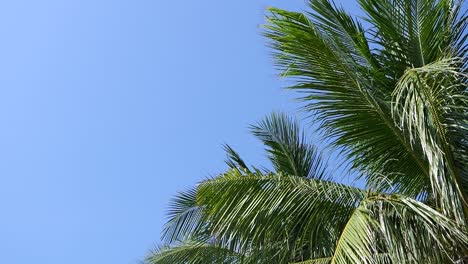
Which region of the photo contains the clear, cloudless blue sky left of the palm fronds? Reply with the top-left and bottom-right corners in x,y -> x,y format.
0,0 -> 362,264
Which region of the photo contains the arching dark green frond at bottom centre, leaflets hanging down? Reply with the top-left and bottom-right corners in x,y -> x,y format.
197,170 -> 365,261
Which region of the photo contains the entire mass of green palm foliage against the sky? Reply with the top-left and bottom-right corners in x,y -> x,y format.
147,0 -> 468,263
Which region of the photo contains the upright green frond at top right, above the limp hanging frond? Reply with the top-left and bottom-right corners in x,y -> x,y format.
359,0 -> 464,69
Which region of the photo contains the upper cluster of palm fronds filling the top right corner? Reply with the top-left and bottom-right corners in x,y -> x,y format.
265,0 -> 468,217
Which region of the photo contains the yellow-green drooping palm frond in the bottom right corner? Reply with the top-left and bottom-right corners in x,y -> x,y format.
292,193 -> 468,264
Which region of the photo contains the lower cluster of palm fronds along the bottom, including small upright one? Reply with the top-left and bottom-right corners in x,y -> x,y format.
147,114 -> 468,264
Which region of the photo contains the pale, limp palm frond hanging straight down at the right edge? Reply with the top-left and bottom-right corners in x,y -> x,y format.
393,59 -> 468,222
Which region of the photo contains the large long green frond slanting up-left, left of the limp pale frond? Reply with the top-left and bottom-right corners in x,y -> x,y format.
266,1 -> 430,196
